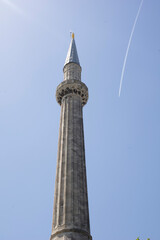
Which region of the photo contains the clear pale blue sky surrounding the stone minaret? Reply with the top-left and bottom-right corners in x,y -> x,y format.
0,0 -> 160,240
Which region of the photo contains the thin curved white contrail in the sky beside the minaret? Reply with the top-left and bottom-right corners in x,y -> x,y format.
119,0 -> 143,97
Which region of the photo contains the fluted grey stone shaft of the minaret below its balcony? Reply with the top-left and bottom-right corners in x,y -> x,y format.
51,88 -> 90,240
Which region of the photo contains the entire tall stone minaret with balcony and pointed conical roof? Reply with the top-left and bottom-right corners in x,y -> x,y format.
50,34 -> 92,240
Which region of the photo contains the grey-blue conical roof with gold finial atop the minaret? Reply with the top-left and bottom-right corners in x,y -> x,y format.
64,33 -> 80,65
